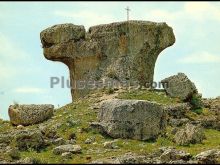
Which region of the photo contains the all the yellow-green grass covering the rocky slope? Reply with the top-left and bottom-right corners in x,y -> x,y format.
0,90 -> 220,163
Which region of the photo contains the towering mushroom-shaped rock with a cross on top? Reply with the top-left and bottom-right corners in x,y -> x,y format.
40,21 -> 175,100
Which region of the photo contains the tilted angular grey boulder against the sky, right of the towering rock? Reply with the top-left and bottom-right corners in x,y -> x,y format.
161,73 -> 198,101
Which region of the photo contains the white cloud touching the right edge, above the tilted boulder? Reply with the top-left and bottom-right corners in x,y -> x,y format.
179,52 -> 220,64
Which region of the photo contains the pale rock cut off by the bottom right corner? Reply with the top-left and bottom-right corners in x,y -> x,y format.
195,149 -> 220,164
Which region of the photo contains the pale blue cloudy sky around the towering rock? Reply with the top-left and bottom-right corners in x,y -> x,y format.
0,2 -> 220,119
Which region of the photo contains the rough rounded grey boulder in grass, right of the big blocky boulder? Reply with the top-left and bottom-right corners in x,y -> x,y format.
174,123 -> 205,145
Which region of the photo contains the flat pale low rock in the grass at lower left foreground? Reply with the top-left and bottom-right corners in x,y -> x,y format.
53,144 -> 82,155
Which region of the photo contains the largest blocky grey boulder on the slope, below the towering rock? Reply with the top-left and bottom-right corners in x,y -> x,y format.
91,99 -> 166,140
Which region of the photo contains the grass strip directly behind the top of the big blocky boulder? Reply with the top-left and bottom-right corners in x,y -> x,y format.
118,89 -> 180,105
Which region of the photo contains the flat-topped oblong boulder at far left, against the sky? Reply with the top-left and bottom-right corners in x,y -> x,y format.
8,104 -> 54,126
